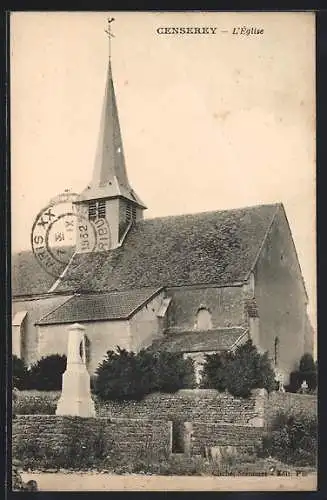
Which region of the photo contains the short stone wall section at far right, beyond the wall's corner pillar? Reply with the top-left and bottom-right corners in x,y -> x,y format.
265,392 -> 318,427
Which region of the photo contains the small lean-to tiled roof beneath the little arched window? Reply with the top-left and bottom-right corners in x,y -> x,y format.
152,327 -> 246,352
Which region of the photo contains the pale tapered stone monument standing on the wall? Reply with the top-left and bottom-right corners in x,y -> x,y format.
56,323 -> 95,417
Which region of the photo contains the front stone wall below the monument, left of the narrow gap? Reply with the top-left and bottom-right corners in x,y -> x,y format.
12,415 -> 172,470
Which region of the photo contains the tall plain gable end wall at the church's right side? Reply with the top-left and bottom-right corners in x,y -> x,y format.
255,205 -> 309,383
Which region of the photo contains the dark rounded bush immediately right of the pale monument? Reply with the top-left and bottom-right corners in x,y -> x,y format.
95,347 -> 195,400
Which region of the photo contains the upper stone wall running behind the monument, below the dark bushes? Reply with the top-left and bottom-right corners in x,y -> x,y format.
13,389 -> 264,425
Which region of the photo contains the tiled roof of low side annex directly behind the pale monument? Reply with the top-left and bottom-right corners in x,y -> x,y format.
37,288 -> 160,325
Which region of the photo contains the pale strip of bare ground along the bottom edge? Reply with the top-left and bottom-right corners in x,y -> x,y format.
22,472 -> 317,491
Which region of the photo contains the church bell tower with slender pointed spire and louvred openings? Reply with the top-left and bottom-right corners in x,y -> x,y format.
75,18 -> 146,253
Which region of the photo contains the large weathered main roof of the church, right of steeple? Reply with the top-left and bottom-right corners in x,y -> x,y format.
52,204 -> 281,292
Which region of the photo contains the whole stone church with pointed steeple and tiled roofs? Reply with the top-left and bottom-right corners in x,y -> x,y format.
12,41 -> 313,380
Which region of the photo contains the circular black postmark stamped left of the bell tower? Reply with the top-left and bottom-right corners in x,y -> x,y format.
31,192 -> 111,278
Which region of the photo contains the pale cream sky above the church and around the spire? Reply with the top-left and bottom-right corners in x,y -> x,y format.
10,12 -> 316,338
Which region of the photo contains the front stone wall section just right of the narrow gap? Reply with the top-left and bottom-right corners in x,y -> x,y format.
190,422 -> 264,455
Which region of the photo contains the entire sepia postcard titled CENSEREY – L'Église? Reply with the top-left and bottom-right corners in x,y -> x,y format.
9,11 -> 317,491
